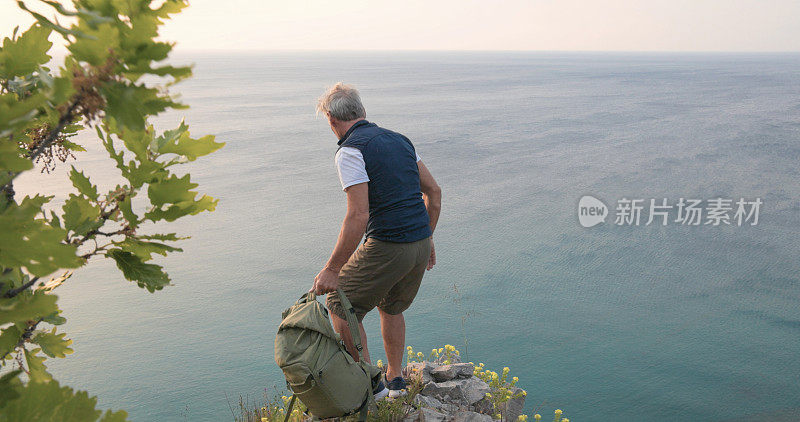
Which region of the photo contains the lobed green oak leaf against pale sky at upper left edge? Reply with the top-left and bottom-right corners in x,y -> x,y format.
0,24 -> 53,79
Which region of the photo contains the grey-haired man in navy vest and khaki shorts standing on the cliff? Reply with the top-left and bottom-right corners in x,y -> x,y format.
312,83 -> 441,398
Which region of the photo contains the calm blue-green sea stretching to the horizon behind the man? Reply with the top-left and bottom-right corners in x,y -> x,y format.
15,52 -> 800,422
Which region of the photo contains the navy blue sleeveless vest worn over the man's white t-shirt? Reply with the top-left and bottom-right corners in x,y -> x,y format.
339,120 -> 431,243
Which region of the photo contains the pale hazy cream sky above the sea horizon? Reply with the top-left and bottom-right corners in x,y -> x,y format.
0,0 -> 800,51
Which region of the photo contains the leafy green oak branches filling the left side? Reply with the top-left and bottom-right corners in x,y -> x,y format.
0,0 -> 223,421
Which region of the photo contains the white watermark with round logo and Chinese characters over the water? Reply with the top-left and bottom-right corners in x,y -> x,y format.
578,195 -> 764,227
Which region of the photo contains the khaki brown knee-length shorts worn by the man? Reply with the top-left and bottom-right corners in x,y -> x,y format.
327,237 -> 431,321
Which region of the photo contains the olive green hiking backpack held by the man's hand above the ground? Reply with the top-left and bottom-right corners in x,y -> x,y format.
275,289 -> 381,421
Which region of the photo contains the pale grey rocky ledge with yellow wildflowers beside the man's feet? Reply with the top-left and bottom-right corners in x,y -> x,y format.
403,355 -> 525,422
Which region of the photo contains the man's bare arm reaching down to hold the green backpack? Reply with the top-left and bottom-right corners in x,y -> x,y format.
311,183 -> 369,295
